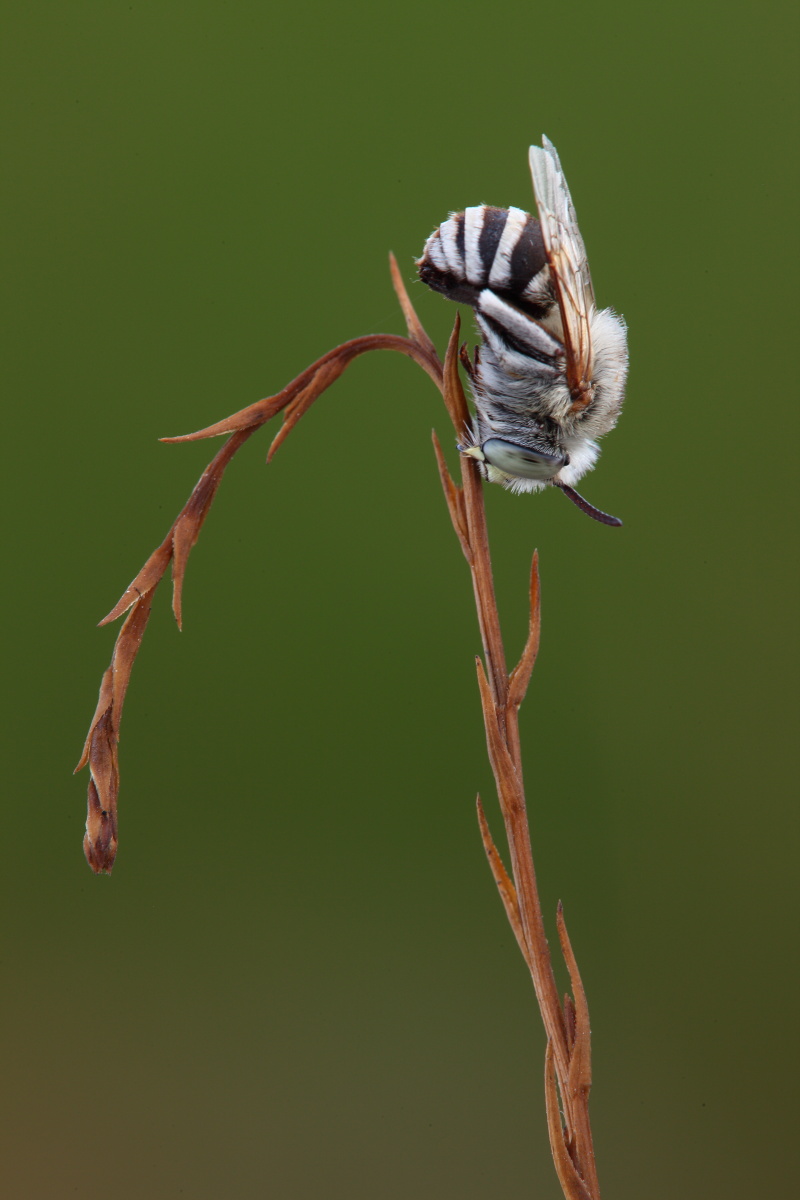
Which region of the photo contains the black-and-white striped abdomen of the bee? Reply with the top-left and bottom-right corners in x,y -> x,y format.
417,204 -> 549,316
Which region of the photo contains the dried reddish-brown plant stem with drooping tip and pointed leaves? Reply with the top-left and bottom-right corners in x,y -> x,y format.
76,256 -> 600,1200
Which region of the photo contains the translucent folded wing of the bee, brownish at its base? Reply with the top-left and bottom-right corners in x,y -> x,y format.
530,137 -> 595,408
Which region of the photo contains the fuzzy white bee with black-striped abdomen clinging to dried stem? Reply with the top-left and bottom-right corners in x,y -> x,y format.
417,138 -> 627,526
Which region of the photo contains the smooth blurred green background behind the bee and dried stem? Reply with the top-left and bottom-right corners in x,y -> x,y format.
0,0 -> 798,1200
